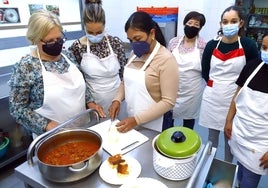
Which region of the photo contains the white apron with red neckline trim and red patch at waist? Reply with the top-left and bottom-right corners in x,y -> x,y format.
199,38 -> 246,131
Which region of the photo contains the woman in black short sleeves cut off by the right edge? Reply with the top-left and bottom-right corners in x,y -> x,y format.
224,35 -> 268,188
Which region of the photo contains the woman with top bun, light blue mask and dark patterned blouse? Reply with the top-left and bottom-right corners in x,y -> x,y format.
69,0 -> 126,118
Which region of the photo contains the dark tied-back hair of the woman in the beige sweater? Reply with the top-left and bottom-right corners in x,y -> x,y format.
125,11 -> 166,47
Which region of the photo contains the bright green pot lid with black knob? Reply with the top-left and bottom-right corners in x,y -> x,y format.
156,126 -> 201,158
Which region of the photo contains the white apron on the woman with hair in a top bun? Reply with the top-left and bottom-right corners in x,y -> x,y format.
81,36 -> 121,114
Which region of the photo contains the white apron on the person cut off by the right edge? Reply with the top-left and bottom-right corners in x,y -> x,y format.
229,63 -> 268,175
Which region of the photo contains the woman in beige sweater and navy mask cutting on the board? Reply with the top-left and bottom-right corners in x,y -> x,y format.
109,12 -> 178,132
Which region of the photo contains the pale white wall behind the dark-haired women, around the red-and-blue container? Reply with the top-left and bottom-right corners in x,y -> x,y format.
103,0 -> 235,42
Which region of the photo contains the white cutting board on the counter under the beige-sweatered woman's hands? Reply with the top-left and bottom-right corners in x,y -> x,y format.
88,120 -> 149,155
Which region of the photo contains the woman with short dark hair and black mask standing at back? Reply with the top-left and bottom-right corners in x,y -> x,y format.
168,11 -> 206,129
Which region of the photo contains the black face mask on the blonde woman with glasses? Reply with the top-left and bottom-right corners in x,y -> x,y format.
42,39 -> 64,56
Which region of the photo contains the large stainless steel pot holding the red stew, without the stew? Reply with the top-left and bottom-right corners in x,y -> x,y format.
27,109 -> 103,182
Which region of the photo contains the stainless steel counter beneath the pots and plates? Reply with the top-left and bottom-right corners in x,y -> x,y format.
15,129 -> 216,188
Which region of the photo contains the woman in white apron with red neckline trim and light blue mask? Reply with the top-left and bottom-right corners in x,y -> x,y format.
199,6 -> 258,162
